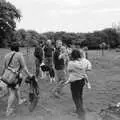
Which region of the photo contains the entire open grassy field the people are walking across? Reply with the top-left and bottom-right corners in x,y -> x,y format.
0,49 -> 120,120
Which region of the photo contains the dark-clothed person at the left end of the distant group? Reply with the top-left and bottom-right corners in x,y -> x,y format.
34,44 -> 43,79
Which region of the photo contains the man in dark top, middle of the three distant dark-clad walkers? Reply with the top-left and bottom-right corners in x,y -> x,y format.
43,40 -> 54,79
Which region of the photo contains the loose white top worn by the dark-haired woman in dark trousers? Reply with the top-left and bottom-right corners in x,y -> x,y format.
68,58 -> 92,82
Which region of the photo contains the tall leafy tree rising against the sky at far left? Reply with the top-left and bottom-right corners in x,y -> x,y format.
0,1 -> 21,46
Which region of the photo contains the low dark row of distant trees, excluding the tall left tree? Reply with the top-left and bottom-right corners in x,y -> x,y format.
4,28 -> 120,49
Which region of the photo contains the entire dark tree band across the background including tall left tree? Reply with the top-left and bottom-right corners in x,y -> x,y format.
0,0 -> 120,49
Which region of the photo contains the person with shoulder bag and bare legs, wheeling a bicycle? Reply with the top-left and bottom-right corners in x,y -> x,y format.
2,43 -> 32,116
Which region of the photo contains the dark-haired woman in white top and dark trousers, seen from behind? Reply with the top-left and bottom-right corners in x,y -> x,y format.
68,49 -> 92,115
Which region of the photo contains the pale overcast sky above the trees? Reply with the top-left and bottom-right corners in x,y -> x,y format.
6,0 -> 120,33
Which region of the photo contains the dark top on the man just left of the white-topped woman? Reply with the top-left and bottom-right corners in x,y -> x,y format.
53,49 -> 64,70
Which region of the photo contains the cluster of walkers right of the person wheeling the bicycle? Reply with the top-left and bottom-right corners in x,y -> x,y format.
34,40 -> 92,114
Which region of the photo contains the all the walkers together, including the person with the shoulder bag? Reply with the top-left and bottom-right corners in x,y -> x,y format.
1,40 -> 92,116
